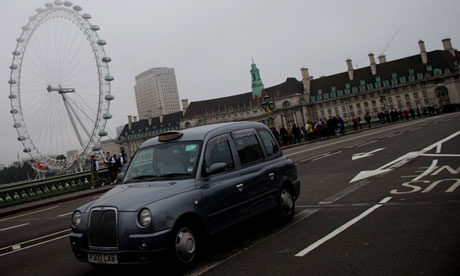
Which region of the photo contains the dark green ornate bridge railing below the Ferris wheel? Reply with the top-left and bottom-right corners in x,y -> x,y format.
0,169 -> 110,208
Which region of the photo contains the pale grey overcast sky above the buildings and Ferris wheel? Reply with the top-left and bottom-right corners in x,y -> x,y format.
0,0 -> 460,165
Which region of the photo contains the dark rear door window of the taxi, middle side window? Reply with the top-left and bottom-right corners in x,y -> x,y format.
232,130 -> 264,166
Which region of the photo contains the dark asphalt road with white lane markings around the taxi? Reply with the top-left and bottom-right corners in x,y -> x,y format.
0,113 -> 460,276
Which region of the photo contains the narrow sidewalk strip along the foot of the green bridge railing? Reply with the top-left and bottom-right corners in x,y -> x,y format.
0,185 -> 115,218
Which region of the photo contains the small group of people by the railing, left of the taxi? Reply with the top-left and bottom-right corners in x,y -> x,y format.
90,148 -> 128,188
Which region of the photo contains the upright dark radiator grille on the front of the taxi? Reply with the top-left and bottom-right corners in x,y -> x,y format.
88,208 -> 118,248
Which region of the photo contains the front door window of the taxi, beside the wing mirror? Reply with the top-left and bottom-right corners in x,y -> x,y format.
205,135 -> 235,170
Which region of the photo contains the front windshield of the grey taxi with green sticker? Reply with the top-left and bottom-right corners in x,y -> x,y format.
123,141 -> 200,183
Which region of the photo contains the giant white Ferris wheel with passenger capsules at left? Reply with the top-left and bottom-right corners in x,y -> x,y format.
8,0 -> 114,169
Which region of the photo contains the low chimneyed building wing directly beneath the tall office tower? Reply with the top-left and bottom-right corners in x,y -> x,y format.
117,111 -> 183,158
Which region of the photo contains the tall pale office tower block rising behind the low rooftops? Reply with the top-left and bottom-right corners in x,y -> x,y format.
134,67 -> 181,120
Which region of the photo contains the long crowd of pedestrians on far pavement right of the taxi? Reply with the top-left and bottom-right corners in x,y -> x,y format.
272,104 -> 460,146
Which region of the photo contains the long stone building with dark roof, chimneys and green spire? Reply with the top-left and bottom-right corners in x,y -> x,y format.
181,39 -> 460,129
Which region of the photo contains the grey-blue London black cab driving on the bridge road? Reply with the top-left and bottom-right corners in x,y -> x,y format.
70,122 -> 300,266
